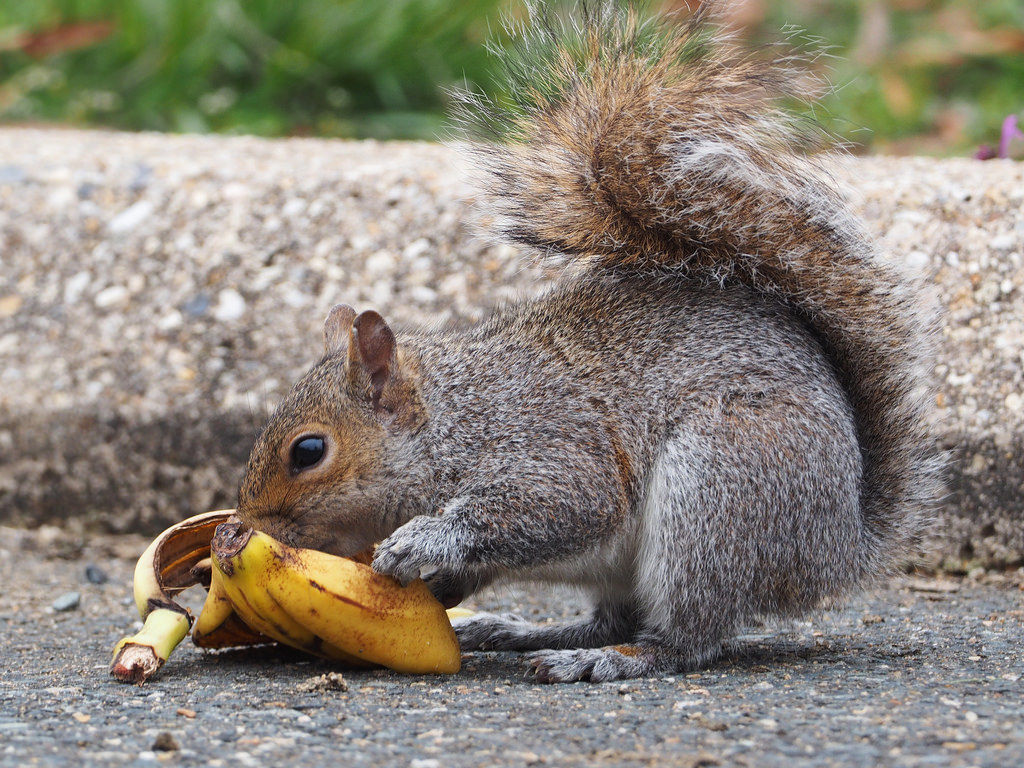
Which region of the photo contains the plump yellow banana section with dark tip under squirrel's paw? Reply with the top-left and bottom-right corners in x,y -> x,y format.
211,522 -> 461,673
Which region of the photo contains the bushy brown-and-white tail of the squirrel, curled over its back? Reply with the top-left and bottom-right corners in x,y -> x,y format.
461,3 -> 939,572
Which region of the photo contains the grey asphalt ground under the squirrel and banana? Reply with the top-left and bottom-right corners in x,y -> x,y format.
0,528 -> 1024,768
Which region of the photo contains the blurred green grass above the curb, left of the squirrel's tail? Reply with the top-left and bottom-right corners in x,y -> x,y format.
0,0 -> 499,138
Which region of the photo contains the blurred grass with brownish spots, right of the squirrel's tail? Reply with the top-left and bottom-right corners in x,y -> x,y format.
744,0 -> 1024,155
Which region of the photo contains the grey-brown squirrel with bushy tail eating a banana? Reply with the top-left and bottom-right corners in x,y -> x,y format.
237,3 -> 941,682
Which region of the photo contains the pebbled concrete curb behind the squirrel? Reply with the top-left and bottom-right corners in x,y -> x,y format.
0,128 -> 1024,570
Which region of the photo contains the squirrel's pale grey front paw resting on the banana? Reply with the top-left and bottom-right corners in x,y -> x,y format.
373,515 -> 456,587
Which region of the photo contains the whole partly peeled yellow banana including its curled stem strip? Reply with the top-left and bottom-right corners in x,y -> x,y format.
111,510 -> 465,683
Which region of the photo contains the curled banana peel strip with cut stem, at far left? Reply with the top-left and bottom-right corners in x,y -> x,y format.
111,510 -> 234,683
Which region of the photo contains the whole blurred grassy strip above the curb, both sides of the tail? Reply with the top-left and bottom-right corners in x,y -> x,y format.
0,0 -> 1024,154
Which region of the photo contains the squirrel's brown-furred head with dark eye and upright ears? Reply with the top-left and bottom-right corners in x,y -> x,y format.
238,304 -> 426,556
